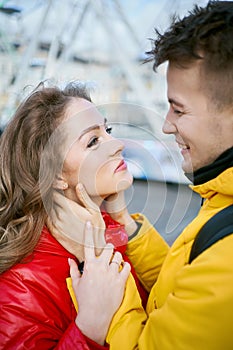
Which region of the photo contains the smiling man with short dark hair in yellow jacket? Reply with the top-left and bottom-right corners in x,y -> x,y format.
56,1 -> 233,350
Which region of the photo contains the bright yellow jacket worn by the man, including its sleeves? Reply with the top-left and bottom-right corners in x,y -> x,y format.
67,168 -> 233,350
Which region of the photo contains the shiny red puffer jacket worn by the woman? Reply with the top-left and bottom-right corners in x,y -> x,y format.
0,228 -> 106,350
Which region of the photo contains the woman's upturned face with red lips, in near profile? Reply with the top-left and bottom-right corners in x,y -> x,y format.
59,98 -> 133,203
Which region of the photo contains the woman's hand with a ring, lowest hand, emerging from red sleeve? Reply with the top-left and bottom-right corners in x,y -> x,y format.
69,223 -> 130,345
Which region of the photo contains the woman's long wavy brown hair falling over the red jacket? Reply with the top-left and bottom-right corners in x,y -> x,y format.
0,82 -> 91,273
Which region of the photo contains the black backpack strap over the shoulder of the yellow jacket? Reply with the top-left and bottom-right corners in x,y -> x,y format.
189,205 -> 233,263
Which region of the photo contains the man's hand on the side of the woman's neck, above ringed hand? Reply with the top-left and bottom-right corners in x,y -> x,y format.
47,184 -> 106,261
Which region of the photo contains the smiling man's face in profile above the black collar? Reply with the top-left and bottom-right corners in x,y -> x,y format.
163,63 -> 233,173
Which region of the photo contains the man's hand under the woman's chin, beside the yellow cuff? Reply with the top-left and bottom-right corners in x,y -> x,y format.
103,191 -> 137,236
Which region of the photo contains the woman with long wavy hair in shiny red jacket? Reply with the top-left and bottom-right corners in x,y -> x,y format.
0,83 -> 146,350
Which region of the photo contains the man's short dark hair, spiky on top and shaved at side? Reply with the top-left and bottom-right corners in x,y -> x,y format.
146,1 -> 233,109
